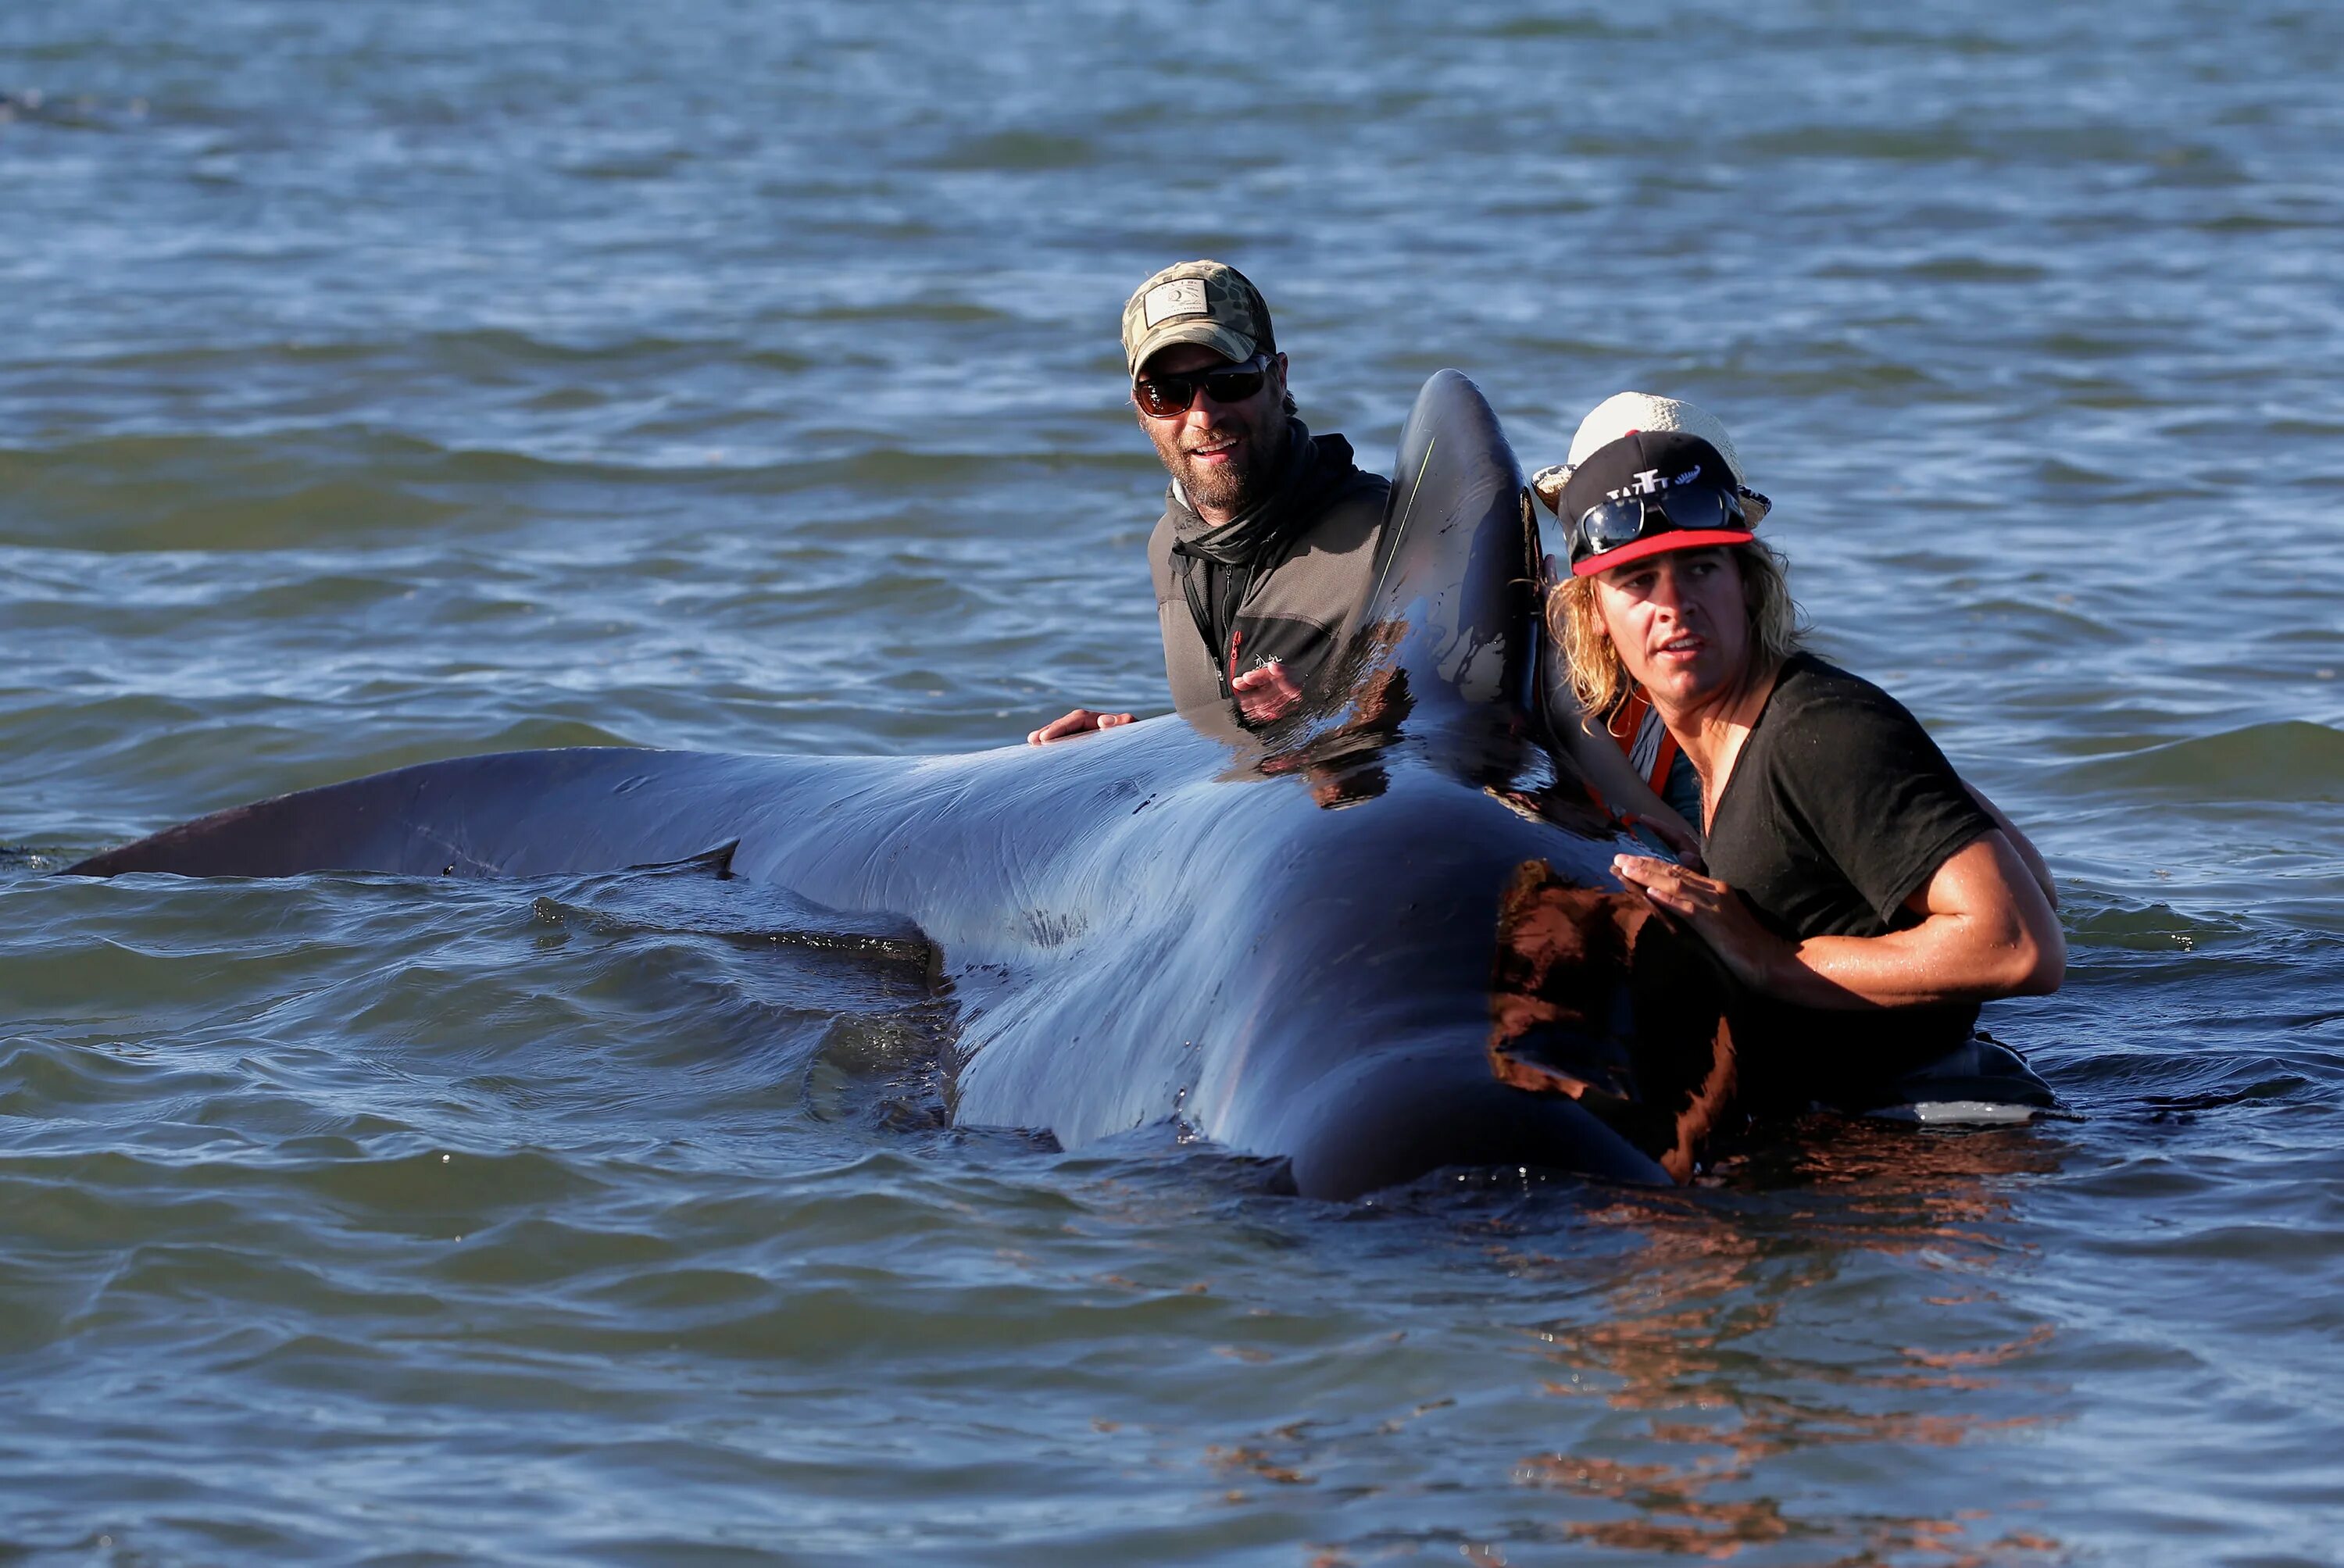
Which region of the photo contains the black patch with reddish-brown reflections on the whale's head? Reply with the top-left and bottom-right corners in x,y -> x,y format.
1488,860 -> 1735,1181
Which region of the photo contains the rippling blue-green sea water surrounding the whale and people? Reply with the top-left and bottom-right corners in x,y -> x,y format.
0,0 -> 2344,1566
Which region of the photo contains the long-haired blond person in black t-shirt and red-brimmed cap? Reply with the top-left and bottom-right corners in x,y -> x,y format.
1540,394 -> 2067,1102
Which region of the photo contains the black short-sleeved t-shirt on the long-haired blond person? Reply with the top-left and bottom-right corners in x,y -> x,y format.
1704,654 -> 1995,1099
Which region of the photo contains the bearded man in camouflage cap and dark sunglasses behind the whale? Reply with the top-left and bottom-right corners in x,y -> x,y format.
1027,260 -> 1390,743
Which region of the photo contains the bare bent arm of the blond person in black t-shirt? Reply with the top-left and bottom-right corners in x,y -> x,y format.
1613,832 -> 2067,1010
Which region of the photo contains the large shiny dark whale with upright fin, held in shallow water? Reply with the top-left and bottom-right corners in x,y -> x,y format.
73,370 -> 1763,1198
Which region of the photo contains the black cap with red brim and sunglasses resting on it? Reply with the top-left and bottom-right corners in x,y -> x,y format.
1554,431 -> 1770,577
